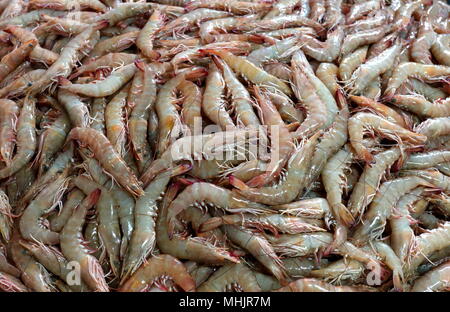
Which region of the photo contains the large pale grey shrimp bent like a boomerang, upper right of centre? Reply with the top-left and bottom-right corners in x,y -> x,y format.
291,51 -> 338,138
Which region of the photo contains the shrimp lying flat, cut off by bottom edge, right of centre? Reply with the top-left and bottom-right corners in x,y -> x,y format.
275,278 -> 377,292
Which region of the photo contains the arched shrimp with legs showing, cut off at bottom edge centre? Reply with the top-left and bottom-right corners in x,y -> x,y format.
197,263 -> 262,292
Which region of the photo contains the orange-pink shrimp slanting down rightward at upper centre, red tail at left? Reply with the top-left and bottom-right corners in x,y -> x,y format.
202,49 -> 292,95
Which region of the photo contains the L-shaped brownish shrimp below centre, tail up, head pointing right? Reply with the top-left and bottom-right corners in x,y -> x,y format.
156,184 -> 239,265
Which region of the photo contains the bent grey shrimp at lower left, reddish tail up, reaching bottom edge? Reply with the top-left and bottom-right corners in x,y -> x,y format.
61,189 -> 109,292
